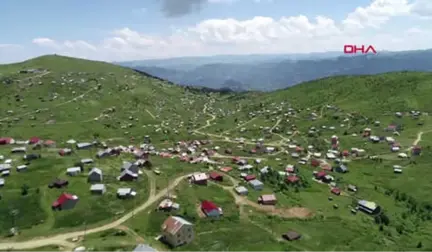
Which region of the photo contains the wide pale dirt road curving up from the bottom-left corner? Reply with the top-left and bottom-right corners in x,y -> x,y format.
0,175 -> 189,250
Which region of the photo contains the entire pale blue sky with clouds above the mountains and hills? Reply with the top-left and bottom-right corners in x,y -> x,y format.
0,0 -> 432,63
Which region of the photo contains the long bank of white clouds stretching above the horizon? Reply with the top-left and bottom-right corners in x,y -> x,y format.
33,0 -> 432,60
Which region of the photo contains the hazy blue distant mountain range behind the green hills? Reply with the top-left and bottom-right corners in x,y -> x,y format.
117,50 -> 432,91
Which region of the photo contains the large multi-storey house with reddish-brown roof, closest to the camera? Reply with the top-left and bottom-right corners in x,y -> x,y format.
161,216 -> 194,247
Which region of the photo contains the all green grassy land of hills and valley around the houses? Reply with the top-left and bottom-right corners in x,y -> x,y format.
0,56 -> 432,252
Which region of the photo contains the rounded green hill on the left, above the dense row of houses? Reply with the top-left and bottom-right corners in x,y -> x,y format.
0,56 -> 216,142
